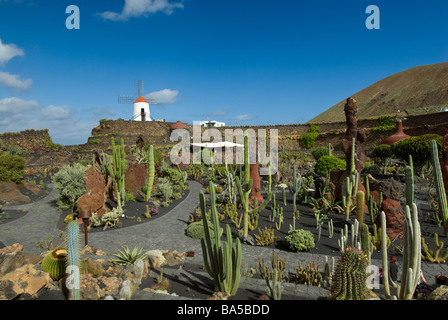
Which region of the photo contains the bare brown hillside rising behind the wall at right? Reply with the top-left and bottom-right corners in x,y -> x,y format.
308,62 -> 448,123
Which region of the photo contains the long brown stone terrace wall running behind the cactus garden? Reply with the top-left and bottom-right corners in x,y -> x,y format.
0,112 -> 448,172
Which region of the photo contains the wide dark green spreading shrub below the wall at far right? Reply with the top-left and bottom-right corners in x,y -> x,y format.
392,134 -> 443,172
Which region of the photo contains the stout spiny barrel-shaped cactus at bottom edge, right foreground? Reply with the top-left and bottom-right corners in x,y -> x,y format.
330,247 -> 368,300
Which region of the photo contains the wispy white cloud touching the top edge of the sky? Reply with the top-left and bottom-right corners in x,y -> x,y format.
99,0 -> 184,21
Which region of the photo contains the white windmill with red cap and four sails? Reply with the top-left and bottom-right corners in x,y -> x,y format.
118,80 -> 157,121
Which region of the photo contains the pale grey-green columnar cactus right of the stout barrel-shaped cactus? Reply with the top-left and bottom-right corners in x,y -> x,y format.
381,203 -> 422,300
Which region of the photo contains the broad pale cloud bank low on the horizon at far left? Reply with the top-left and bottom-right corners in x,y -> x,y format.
0,97 -> 97,145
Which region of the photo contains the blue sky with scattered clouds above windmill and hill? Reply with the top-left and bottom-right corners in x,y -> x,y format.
0,0 -> 448,145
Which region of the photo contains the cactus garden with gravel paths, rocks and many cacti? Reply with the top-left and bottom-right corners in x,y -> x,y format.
0,108 -> 448,301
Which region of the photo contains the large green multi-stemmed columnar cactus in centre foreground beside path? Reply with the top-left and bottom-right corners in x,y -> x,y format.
199,182 -> 241,296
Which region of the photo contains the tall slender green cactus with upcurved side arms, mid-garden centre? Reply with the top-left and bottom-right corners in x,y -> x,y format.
235,131 -> 272,240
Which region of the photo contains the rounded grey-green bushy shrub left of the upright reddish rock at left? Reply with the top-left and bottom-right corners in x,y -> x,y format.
53,163 -> 87,210
